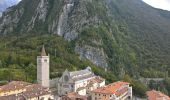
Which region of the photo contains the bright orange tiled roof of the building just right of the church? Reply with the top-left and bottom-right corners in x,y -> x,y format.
92,81 -> 129,95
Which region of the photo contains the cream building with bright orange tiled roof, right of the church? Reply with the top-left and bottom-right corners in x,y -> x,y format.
91,81 -> 132,100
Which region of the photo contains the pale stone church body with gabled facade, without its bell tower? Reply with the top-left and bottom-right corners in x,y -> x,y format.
58,67 -> 105,95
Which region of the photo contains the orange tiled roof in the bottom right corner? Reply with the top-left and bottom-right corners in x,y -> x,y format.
146,90 -> 170,100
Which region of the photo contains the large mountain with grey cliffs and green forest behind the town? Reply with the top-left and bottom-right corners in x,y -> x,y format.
0,0 -> 170,96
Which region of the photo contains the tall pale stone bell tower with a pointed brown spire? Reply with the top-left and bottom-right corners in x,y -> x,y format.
37,45 -> 50,88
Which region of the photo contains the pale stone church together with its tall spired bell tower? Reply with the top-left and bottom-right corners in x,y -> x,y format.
37,46 -> 105,96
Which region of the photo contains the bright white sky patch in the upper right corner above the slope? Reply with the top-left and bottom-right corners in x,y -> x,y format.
143,0 -> 170,11
